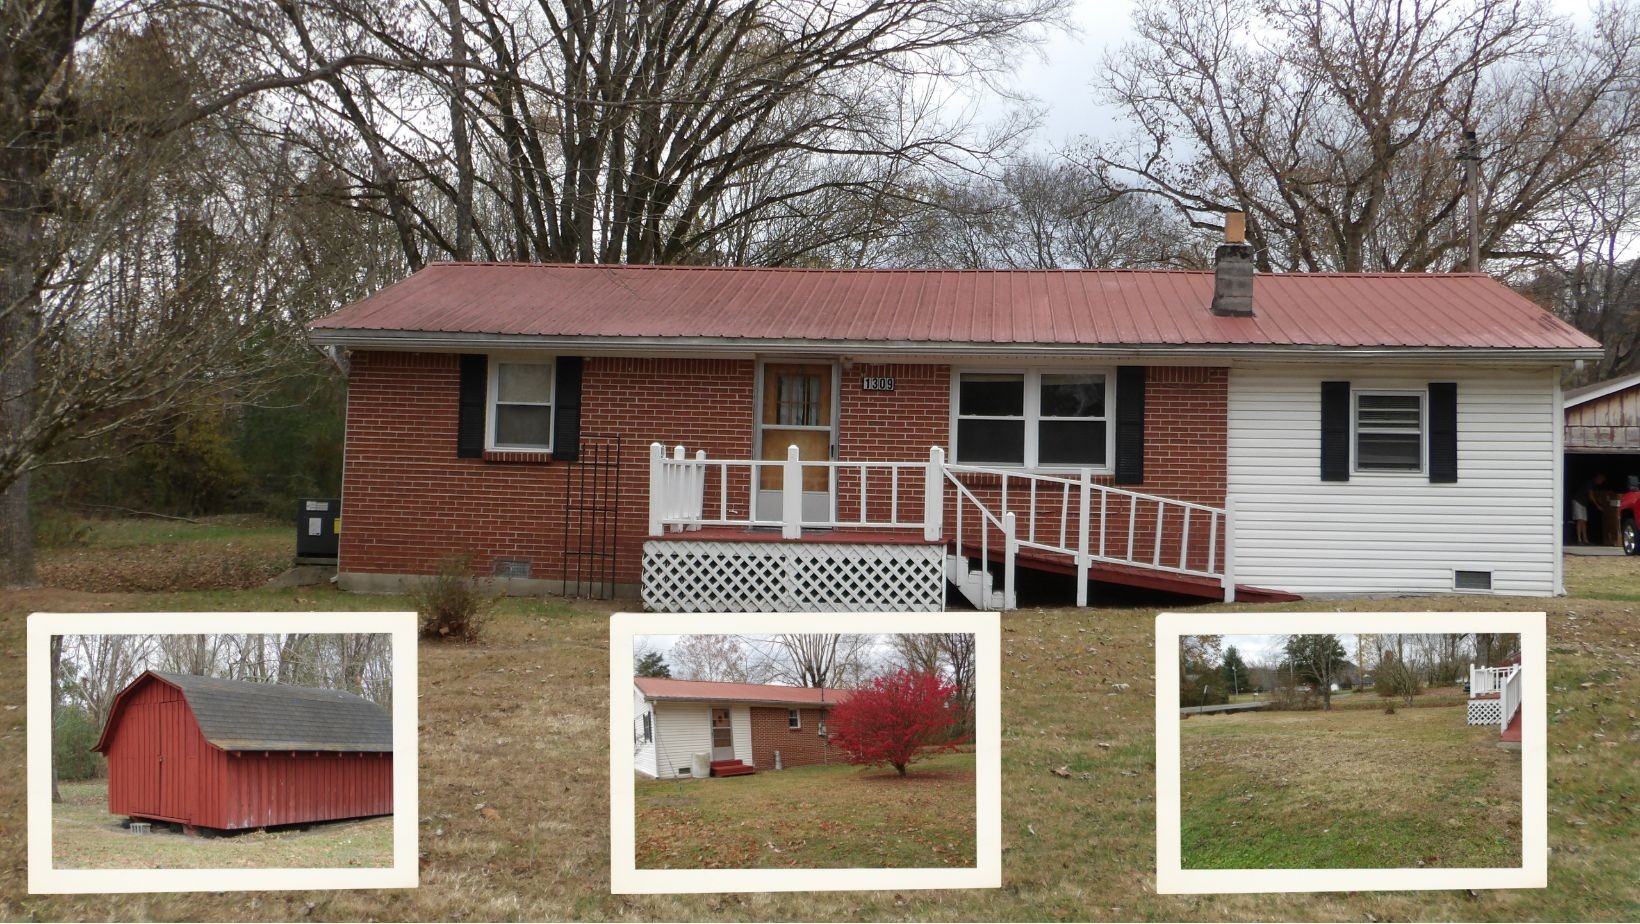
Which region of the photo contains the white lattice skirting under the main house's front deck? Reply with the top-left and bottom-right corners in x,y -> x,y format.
643,538 -> 945,612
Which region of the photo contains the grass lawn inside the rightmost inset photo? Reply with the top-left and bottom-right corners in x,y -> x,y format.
1179,706 -> 1520,870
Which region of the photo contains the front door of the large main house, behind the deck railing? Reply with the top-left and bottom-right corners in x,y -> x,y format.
758,363 -> 836,522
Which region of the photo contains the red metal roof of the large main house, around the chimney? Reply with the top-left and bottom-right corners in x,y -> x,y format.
312,263 -> 1599,350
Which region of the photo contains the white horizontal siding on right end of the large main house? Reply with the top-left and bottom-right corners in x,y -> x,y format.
1228,364 -> 1560,596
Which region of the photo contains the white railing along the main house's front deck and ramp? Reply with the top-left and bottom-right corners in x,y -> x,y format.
649,443 -> 1235,606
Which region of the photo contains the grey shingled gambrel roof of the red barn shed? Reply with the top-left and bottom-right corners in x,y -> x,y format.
92,671 -> 394,753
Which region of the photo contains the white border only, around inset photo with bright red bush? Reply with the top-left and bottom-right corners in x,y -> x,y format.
610,612 -> 1002,894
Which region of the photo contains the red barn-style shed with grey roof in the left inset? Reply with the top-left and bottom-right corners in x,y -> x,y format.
92,671 -> 394,830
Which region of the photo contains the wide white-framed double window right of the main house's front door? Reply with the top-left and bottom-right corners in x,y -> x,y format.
953,371 -> 1110,468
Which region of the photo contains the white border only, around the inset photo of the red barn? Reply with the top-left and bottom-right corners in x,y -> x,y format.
26,612 -> 421,894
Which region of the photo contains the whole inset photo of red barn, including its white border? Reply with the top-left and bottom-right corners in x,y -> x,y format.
26,612 -> 420,894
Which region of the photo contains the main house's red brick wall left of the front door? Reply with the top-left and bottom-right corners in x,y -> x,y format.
339,351 -> 754,583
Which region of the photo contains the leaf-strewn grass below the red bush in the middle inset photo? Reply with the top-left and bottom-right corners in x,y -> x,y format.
636,753 -> 976,870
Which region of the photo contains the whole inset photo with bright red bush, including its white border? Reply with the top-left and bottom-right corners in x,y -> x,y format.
610,612 -> 1002,894
